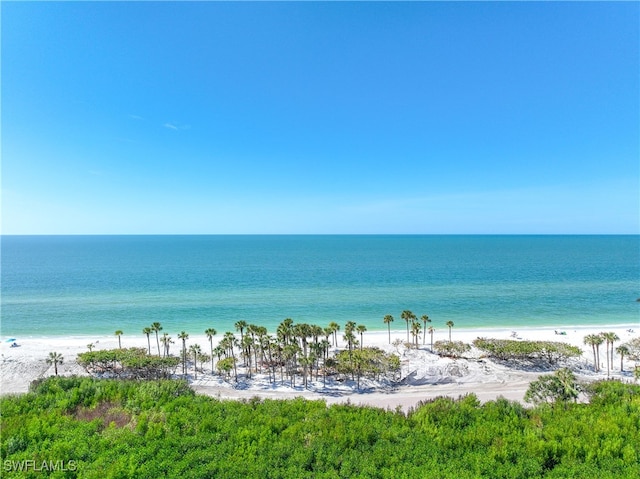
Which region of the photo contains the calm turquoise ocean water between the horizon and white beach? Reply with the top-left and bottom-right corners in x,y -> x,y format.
1,235 -> 640,337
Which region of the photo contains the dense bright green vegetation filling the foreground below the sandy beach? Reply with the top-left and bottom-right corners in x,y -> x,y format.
0,377 -> 640,479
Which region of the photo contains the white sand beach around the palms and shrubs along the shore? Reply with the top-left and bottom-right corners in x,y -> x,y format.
0,325 -> 640,411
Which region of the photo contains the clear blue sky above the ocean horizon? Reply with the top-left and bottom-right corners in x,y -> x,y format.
1,2 -> 640,234
